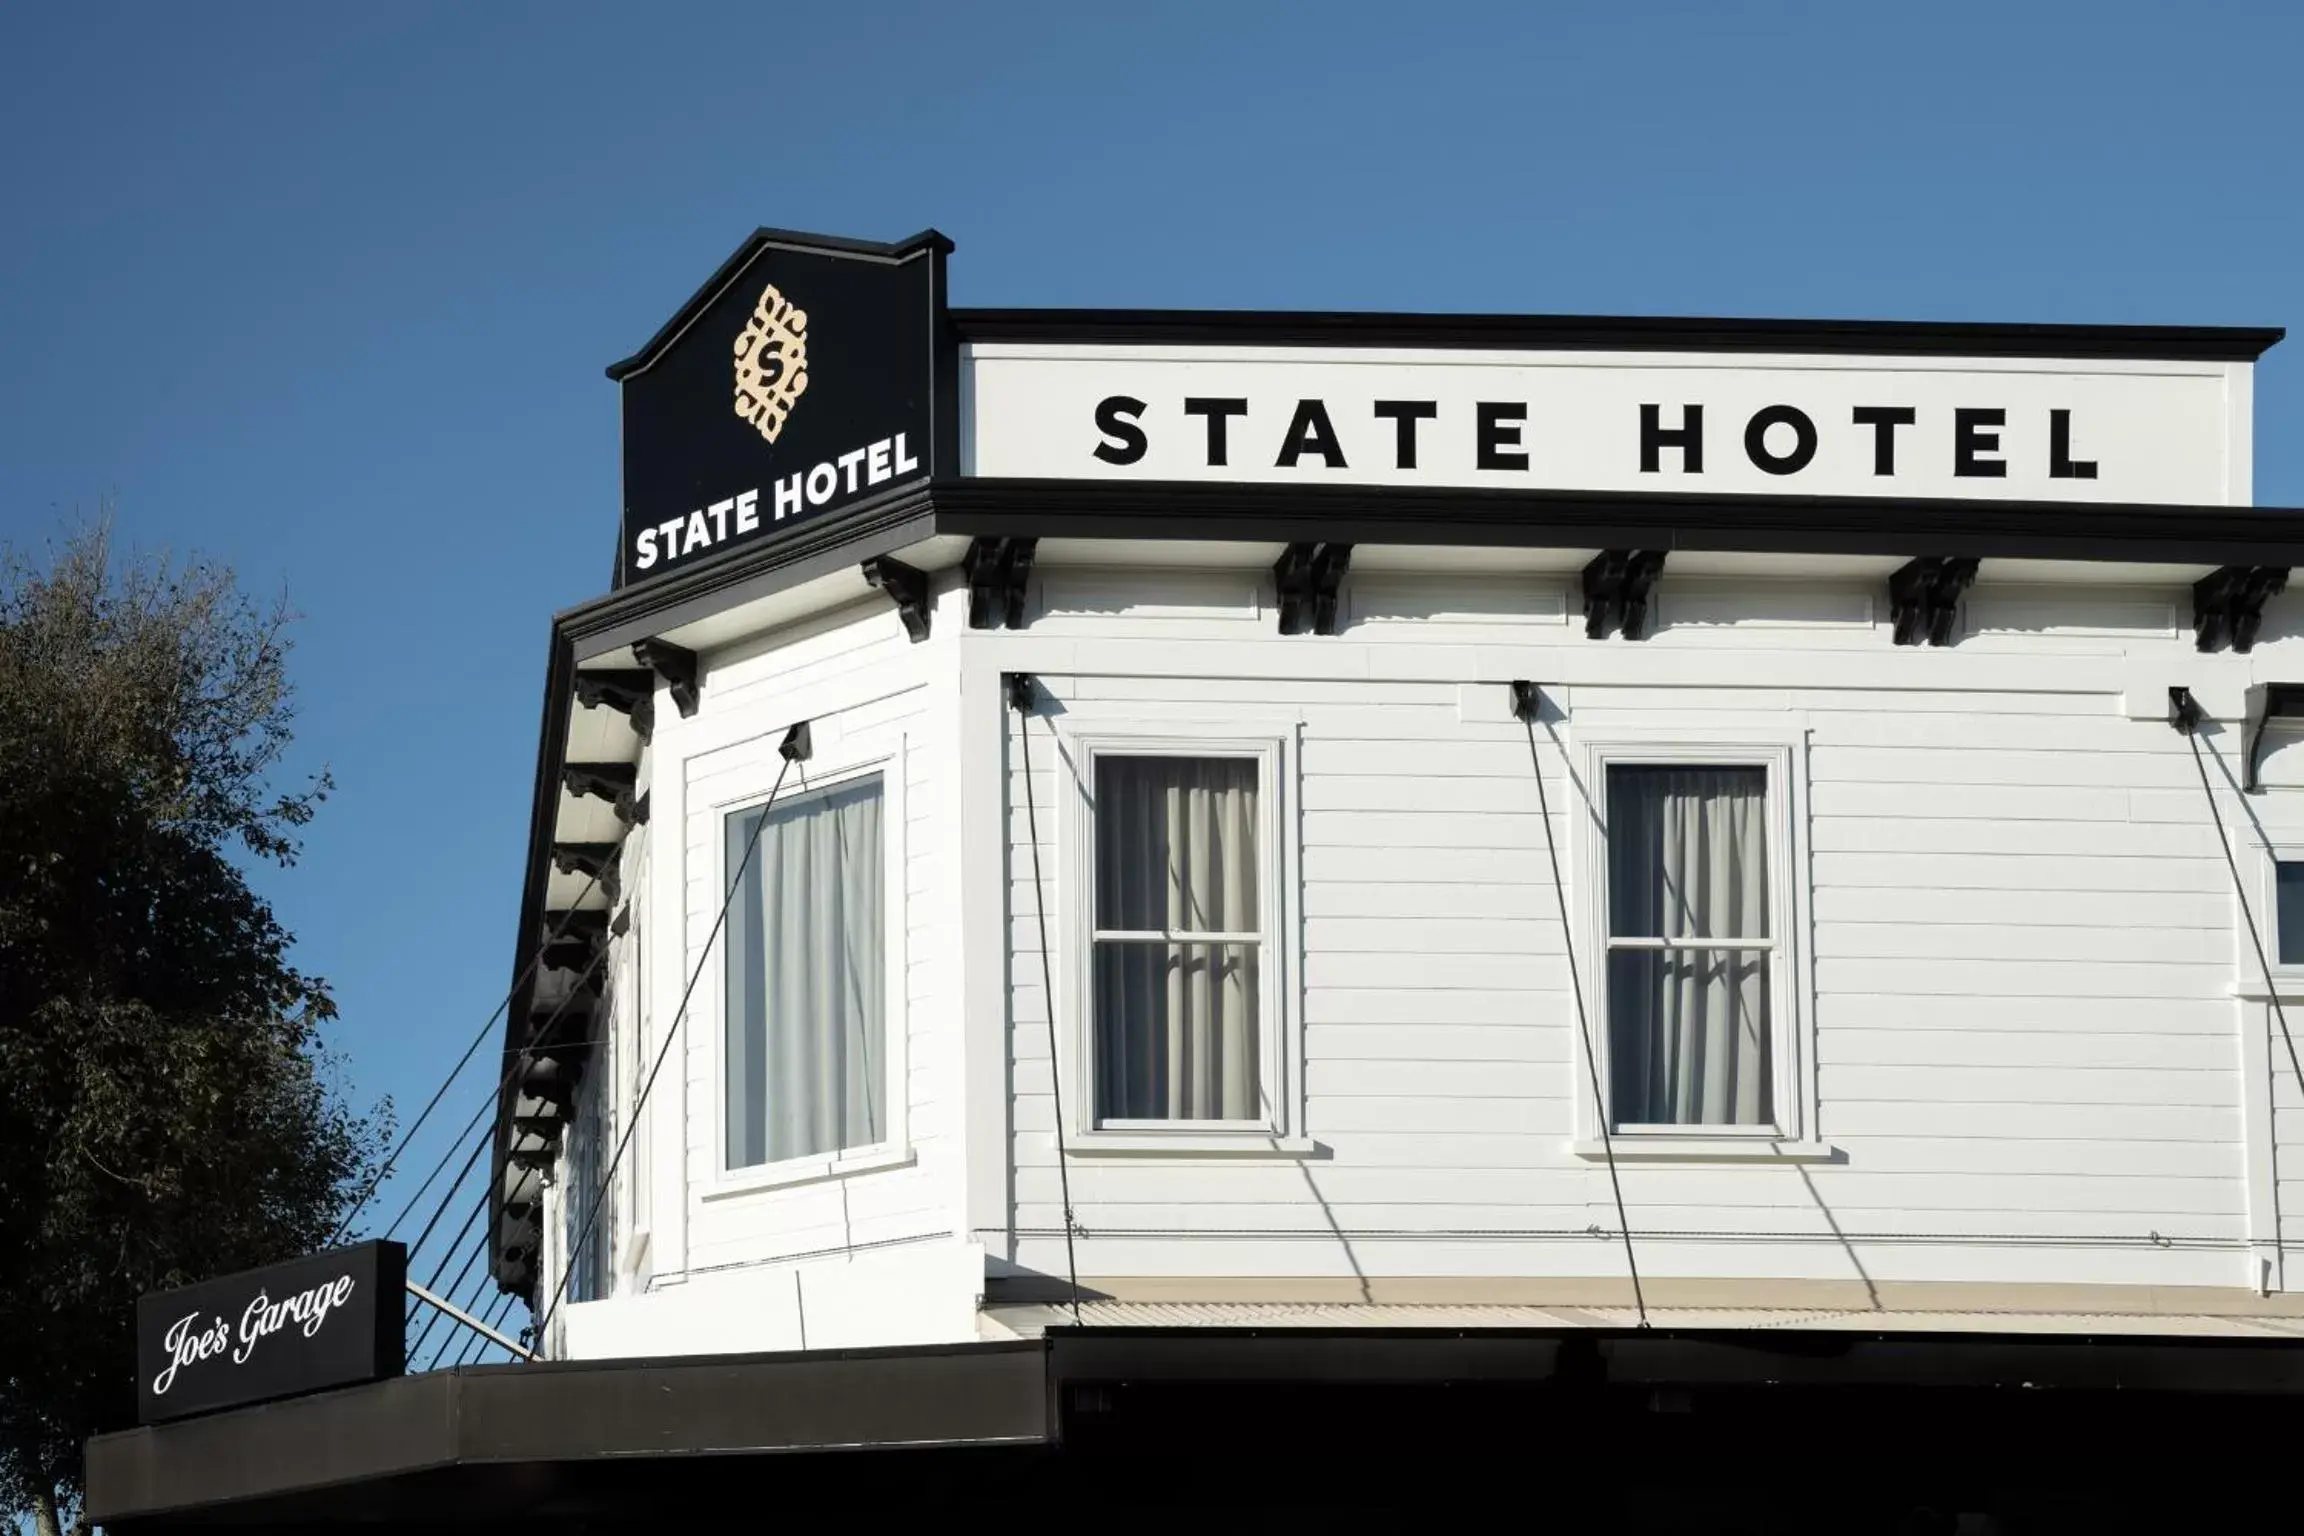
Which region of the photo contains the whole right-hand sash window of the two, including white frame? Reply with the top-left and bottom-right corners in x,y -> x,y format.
1562,725 -> 1832,1161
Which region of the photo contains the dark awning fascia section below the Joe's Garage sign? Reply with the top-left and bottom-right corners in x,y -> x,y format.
88,1340 -> 1048,1531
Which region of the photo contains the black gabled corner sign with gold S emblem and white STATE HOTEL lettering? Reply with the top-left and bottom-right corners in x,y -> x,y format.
608,230 -> 958,585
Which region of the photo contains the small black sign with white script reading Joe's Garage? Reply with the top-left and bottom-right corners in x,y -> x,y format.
136,1244 -> 408,1423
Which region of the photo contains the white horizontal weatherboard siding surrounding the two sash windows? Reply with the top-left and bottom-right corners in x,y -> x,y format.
1007,644 -> 2257,1285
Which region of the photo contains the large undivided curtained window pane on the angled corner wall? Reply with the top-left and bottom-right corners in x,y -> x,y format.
726,778 -> 887,1168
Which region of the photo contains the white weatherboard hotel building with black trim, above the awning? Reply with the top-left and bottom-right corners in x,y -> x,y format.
495,233 -> 2304,1359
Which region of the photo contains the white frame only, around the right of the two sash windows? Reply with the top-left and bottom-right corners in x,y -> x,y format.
1567,725 -> 1836,1163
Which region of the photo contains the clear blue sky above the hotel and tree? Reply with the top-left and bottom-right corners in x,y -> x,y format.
0,0 -> 2304,1335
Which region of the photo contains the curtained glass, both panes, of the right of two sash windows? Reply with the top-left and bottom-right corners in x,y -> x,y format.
1608,765 -> 1774,1126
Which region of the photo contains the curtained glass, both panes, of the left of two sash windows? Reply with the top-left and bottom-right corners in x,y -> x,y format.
1094,758 -> 1260,1121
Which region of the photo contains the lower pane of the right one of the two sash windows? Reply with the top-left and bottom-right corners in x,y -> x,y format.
1608,949 -> 1774,1126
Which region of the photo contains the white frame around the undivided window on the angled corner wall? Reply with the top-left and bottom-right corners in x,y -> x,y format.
689,730 -> 912,1200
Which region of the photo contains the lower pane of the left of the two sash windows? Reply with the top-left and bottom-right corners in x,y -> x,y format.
1094,940 -> 1260,1121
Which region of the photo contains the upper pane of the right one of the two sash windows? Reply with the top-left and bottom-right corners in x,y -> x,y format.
1608,762 -> 1767,940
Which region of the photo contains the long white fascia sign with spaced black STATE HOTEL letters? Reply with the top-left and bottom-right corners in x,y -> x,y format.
963,343 -> 2251,507
